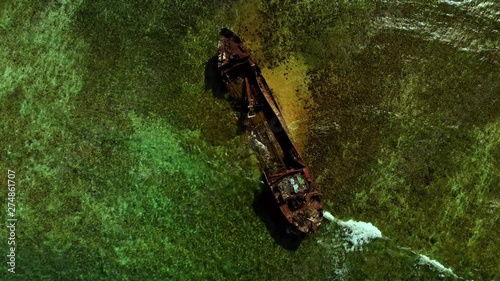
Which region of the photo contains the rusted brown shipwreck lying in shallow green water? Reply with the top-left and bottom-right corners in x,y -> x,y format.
218,28 -> 323,233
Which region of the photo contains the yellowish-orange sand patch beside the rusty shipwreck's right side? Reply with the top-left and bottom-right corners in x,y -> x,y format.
262,57 -> 315,152
